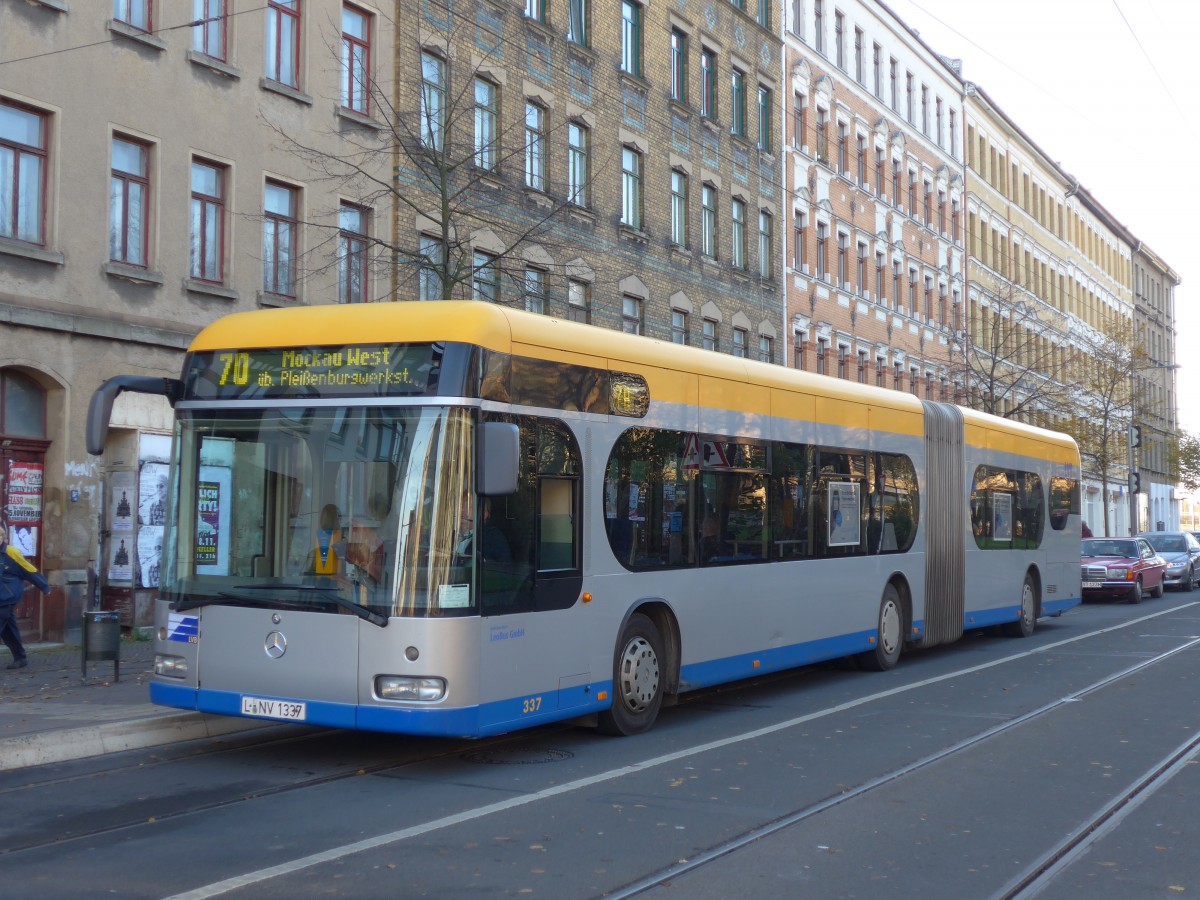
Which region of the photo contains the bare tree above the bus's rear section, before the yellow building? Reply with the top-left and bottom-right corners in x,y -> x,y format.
950,278 -> 1072,424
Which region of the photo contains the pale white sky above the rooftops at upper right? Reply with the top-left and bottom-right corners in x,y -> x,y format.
884,0 -> 1200,434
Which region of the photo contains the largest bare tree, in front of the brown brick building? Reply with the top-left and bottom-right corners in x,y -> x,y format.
260,0 -> 613,308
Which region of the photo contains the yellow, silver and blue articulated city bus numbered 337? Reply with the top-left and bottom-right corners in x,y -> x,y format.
88,302 -> 1080,736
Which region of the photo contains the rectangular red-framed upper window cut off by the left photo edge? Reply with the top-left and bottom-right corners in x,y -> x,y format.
0,101 -> 48,245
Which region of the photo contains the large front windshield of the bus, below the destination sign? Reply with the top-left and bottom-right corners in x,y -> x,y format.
160,407 -> 478,624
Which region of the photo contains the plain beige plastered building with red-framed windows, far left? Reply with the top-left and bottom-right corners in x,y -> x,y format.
0,0 -> 392,641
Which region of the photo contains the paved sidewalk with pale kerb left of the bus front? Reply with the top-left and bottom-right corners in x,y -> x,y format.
0,638 -> 269,772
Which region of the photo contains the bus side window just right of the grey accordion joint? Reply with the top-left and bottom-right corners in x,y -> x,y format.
971,466 -> 1045,550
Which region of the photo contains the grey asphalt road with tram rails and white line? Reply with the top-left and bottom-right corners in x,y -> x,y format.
0,593 -> 1200,900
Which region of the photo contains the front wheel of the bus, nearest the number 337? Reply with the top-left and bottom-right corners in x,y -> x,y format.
599,613 -> 666,736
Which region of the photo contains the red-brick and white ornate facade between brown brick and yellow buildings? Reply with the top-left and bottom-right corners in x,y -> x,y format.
784,0 -> 966,401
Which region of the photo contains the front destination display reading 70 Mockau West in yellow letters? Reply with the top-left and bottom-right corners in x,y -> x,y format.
185,343 -> 440,400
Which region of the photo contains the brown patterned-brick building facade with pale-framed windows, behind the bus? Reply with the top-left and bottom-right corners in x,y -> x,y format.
396,0 -> 781,361
